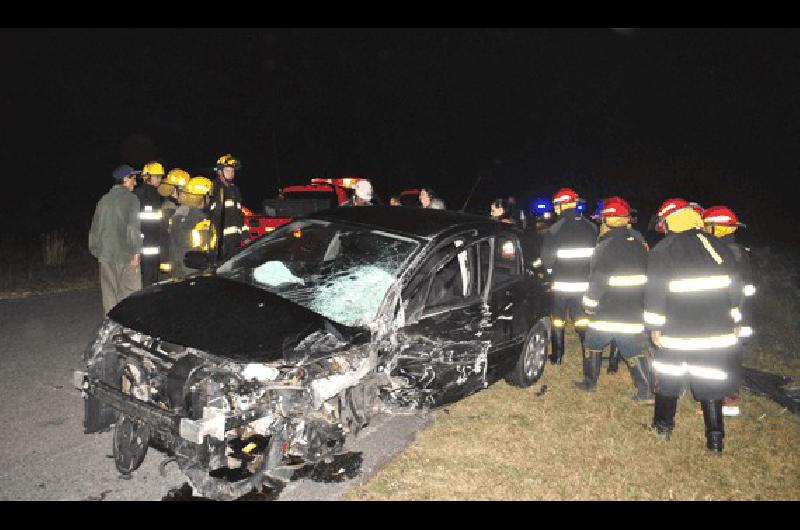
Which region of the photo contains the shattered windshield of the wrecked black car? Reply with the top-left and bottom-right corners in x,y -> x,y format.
217,220 -> 419,326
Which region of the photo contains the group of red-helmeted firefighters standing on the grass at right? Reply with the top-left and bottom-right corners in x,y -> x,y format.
534,188 -> 755,453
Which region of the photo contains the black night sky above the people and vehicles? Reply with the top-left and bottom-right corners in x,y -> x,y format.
0,29 -> 800,248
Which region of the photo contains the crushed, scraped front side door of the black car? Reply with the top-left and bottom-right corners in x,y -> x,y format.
395,238 -> 492,404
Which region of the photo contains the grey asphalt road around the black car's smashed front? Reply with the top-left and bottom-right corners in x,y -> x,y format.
0,289 -> 431,500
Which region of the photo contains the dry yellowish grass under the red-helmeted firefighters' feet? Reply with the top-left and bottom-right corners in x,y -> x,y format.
349,333 -> 800,500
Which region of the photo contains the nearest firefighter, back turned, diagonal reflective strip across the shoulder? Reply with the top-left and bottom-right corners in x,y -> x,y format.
644,199 -> 742,453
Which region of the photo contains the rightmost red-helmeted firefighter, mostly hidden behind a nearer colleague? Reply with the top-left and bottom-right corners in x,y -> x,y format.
703,206 -> 756,416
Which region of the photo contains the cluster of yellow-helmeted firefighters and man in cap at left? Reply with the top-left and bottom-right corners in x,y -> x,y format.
89,154 -> 248,313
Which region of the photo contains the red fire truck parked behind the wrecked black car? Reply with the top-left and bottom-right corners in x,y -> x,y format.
242,178 -> 361,246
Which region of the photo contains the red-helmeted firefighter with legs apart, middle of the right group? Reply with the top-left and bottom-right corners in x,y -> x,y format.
576,197 -> 652,401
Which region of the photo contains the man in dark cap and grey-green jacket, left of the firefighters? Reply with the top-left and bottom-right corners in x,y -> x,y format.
89,165 -> 142,313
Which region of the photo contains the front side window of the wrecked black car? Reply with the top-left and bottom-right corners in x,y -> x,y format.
425,240 -> 481,310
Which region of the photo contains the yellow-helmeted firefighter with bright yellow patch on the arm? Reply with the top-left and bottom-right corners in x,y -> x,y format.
169,177 -> 214,278
